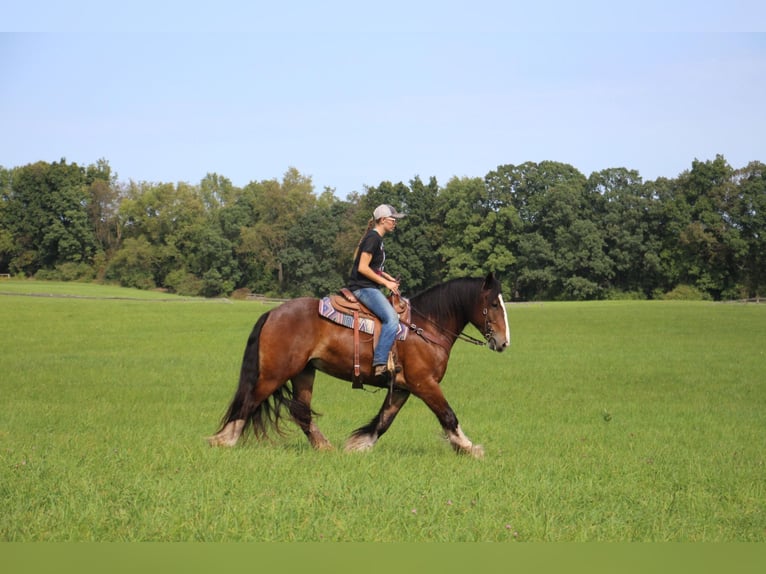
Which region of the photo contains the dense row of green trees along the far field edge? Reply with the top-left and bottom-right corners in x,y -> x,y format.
0,155 -> 766,300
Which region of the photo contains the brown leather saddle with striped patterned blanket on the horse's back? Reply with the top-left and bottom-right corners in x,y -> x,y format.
319,287 -> 410,389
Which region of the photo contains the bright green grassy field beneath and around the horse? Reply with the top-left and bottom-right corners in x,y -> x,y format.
0,280 -> 766,542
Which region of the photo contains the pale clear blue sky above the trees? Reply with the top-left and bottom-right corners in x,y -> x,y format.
0,0 -> 766,198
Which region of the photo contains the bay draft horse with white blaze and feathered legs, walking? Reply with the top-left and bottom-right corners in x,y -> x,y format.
208,273 -> 510,458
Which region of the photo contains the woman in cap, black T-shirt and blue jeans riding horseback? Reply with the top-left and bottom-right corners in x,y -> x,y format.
347,204 -> 406,377
